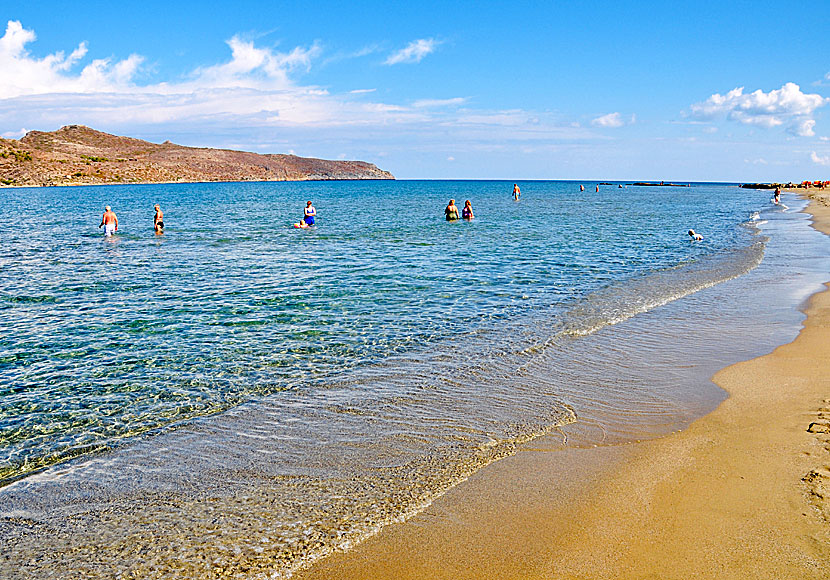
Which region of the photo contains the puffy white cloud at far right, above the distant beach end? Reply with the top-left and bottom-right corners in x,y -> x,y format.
691,83 -> 830,137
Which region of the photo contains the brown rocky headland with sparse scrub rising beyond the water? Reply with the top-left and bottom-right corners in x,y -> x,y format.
0,125 -> 394,186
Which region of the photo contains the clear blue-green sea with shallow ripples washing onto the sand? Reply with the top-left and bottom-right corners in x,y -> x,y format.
0,181 -> 830,579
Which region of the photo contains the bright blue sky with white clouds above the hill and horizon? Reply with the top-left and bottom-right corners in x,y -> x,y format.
0,0 -> 830,182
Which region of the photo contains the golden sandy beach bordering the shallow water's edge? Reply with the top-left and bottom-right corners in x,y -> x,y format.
297,192 -> 830,580
